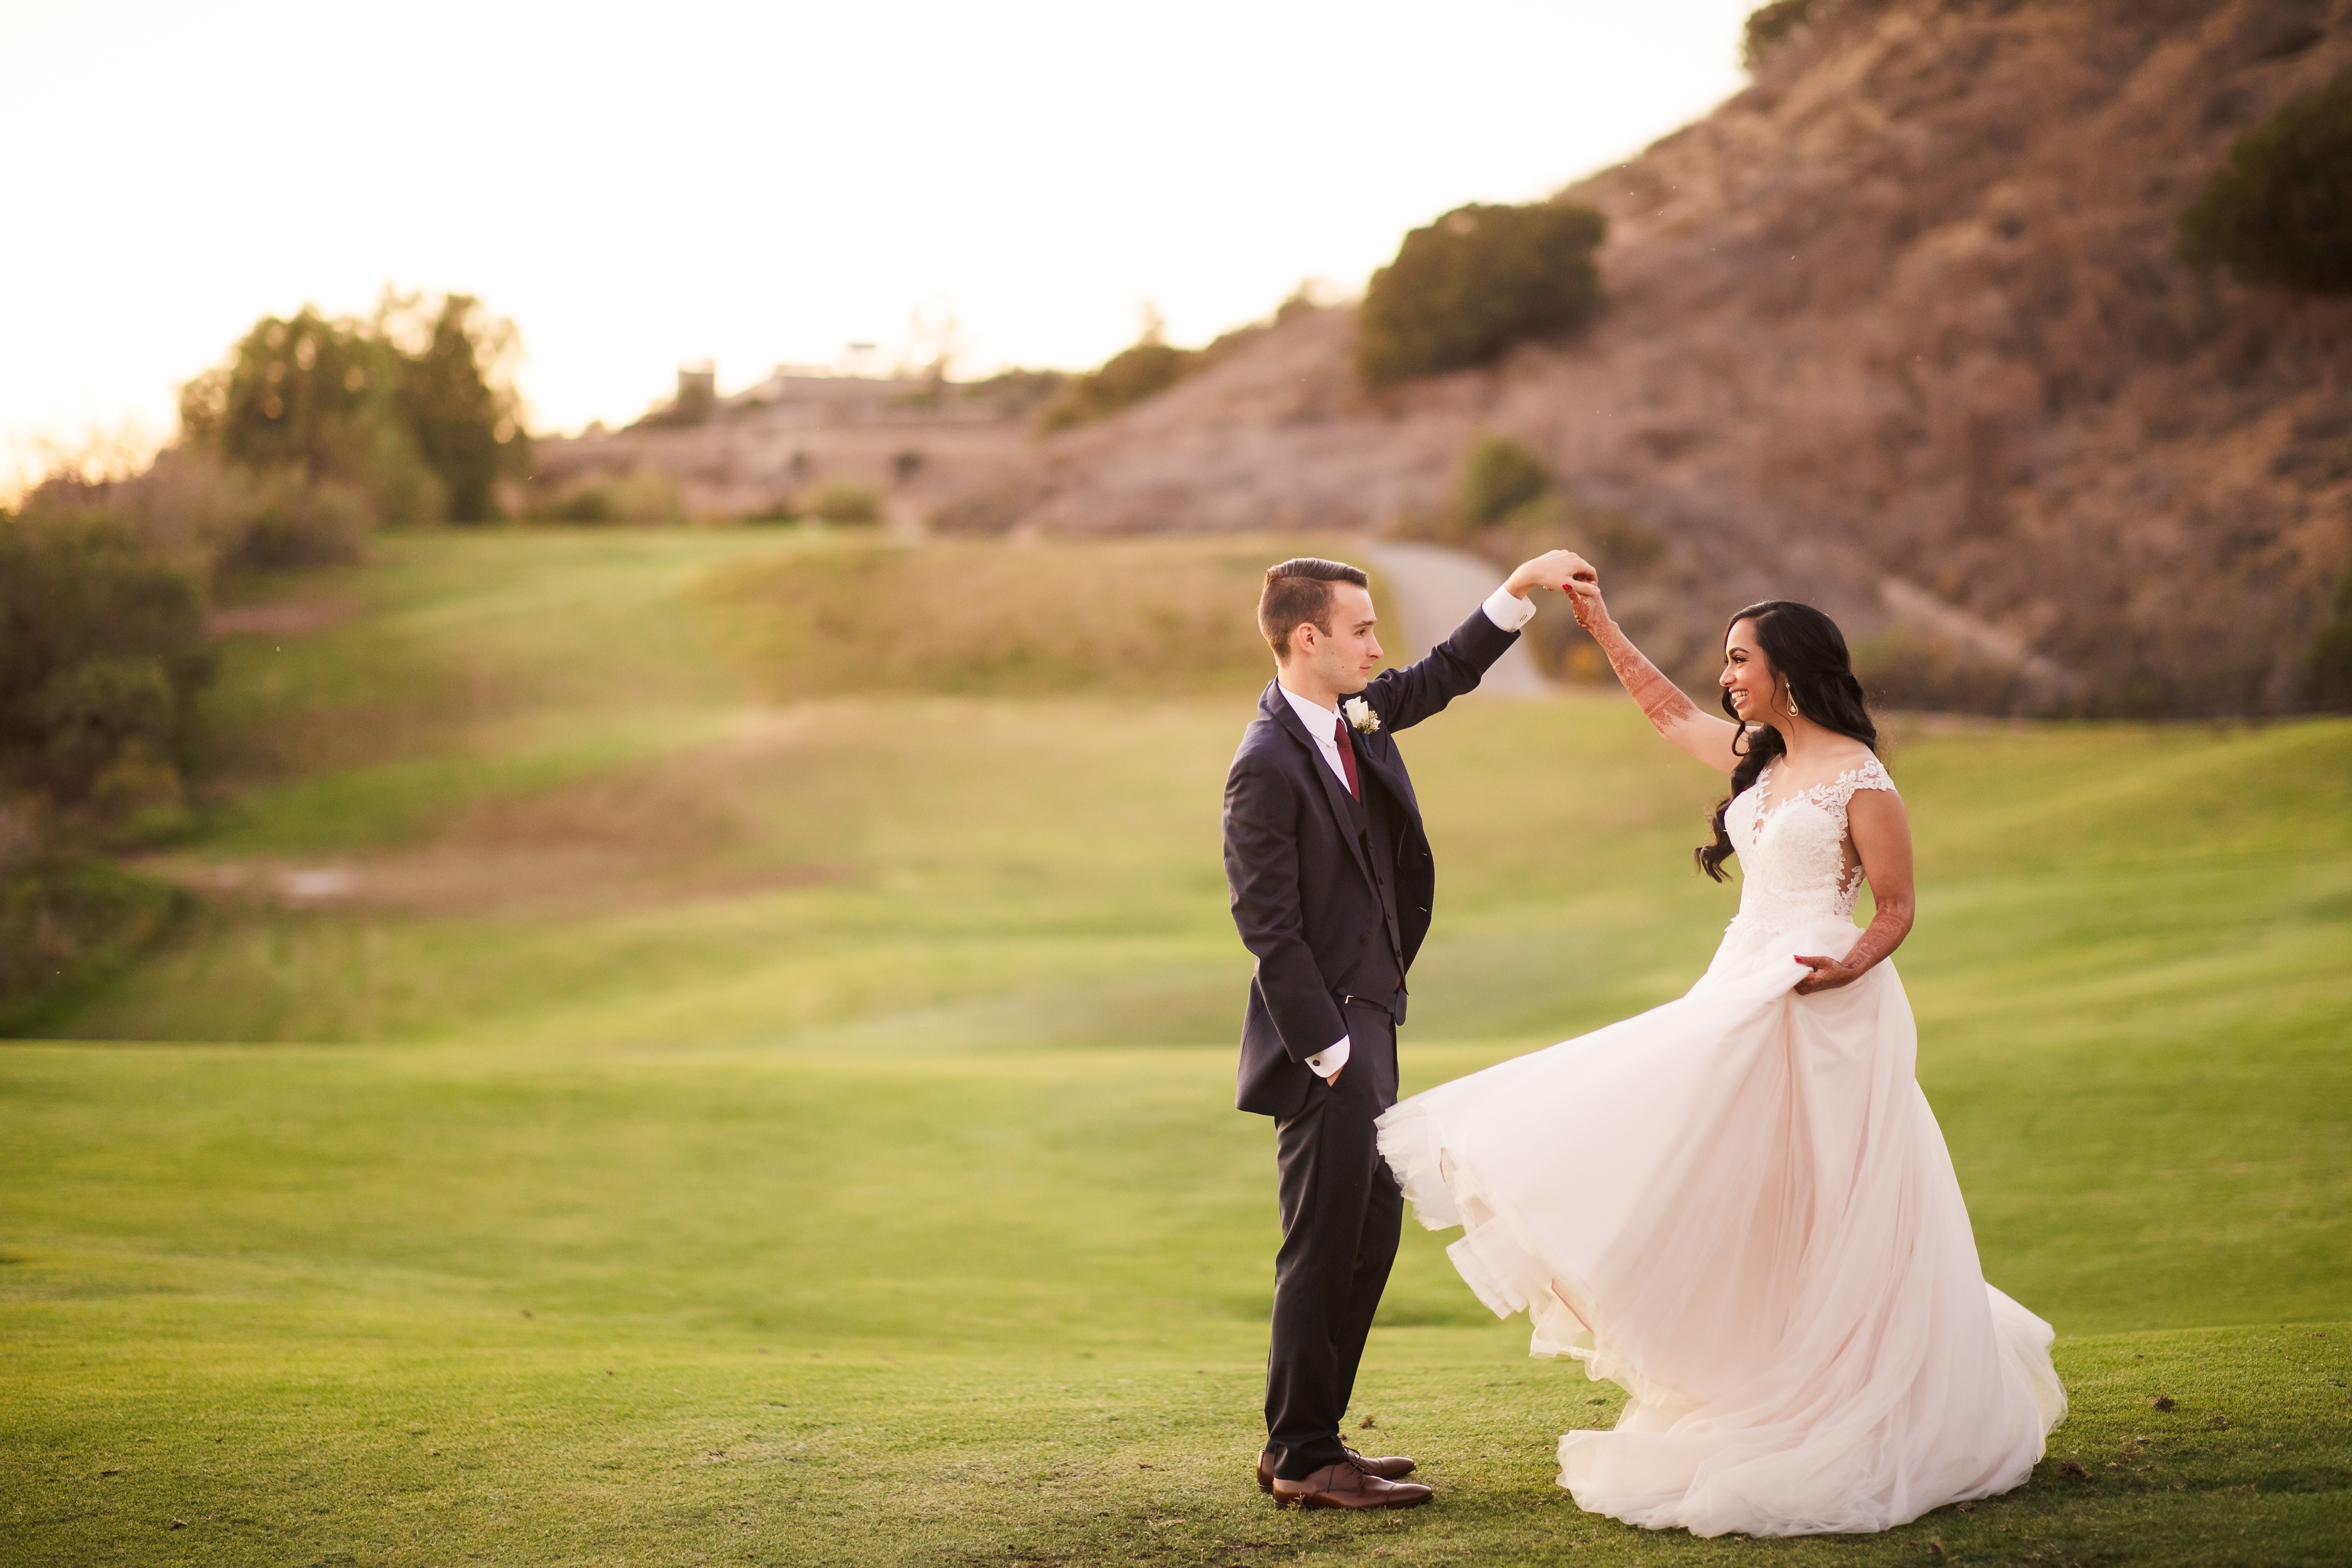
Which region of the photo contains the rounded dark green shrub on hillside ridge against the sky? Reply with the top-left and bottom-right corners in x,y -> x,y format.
1355,202 -> 1609,388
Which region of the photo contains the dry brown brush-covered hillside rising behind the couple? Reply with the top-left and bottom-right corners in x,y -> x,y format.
1021,0 -> 2352,715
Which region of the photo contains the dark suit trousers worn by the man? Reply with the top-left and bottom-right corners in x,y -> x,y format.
1265,1006 -> 1404,1481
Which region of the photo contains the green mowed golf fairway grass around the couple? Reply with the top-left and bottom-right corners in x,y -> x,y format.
0,534 -> 2352,1566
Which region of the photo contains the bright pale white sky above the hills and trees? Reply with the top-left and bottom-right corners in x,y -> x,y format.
0,0 -> 1755,477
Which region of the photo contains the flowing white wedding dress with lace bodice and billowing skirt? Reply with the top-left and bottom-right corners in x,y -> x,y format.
1381,759 -> 2065,1535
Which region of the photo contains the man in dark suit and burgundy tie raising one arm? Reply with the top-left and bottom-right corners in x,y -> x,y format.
1225,550 -> 1590,1509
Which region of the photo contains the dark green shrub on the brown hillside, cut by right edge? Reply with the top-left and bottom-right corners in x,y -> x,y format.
2180,70 -> 2352,294
